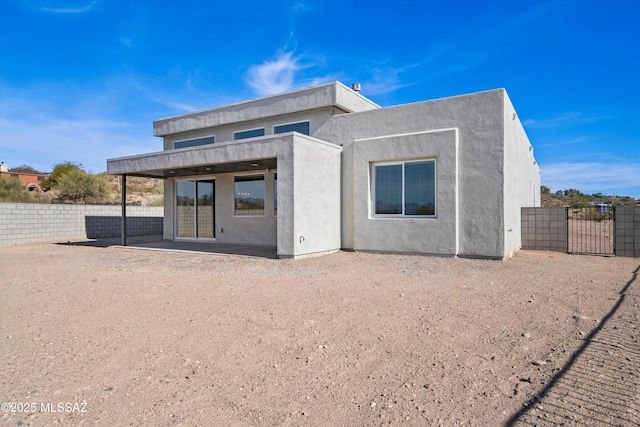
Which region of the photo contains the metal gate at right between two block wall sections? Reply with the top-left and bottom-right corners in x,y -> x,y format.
567,205 -> 616,255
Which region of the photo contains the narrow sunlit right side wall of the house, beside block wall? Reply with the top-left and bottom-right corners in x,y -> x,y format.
503,92 -> 540,256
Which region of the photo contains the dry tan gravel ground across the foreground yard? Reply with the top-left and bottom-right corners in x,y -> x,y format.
0,245 -> 640,426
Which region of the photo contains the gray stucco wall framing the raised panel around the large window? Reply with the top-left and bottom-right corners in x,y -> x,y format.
316,89 -> 505,258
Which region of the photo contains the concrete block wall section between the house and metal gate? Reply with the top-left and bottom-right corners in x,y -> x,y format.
521,208 -> 567,252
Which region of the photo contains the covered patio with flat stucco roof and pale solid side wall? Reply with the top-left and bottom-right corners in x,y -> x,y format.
107,132 -> 341,258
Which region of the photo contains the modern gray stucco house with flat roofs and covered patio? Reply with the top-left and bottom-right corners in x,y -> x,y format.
107,82 -> 540,259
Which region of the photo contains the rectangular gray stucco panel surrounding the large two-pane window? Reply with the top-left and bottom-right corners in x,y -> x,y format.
353,129 -> 458,255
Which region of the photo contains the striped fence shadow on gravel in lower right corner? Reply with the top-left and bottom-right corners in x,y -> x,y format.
505,266 -> 640,427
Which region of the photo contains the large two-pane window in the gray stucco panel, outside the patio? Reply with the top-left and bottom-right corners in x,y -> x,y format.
372,160 -> 436,217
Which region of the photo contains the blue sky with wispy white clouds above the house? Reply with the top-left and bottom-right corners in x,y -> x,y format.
0,0 -> 640,198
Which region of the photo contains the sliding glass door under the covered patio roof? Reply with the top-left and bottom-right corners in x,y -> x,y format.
176,180 -> 216,239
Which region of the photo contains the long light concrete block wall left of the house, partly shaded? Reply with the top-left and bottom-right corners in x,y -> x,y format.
0,203 -> 164,246
